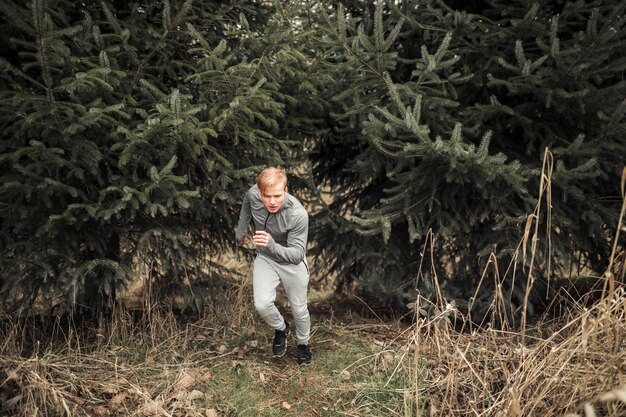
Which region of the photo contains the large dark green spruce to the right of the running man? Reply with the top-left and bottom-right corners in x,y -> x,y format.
312,0 -> 626,312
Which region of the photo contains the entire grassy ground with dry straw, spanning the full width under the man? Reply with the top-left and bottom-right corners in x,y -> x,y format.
0,268 -> 626,417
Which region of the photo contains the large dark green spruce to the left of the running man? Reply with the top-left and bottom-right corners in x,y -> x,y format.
0,0 -> 310,311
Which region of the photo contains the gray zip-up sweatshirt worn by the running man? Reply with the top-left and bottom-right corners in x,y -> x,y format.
235,184 -> 309,265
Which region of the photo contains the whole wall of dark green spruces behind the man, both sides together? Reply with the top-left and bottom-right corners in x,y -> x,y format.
0,0 -> 626,315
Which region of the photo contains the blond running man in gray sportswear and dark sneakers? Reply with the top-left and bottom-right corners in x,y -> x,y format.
235,167 -> 312,365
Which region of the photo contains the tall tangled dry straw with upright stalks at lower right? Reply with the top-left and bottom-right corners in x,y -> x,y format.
400,156 -> 626,417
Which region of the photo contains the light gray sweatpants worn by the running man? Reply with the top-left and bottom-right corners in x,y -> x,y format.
252,255 -> 311,345
